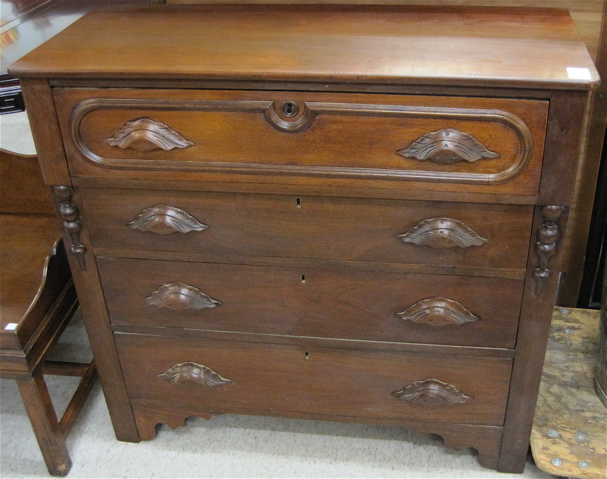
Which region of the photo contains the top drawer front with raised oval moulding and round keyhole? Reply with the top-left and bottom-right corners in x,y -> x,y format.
55,89 -> 548,196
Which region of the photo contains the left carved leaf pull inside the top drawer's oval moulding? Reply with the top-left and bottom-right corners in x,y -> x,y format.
105,117 -> 194,152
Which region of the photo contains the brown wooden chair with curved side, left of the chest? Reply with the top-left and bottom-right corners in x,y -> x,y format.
0,150 -> 96,476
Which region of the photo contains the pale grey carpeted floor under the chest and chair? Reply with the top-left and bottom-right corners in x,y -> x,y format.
0,113 -> 551,479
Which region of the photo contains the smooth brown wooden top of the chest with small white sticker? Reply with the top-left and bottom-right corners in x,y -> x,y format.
11,5 -> 598,89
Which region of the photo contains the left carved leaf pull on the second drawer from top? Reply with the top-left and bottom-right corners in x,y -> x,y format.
126,204 -> 209,235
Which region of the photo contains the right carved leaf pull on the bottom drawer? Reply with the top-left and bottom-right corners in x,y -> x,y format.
392,379 -> 474,407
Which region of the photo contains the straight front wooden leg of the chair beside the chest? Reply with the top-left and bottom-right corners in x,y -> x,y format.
17,374 -> 72,476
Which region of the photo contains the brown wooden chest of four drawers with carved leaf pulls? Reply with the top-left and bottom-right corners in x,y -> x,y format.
12,6 -> 598,472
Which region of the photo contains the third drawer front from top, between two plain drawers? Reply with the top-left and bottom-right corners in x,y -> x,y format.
98,258 -> 523,348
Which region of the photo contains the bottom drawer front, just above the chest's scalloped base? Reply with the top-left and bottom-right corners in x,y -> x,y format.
116,334 -> 511,425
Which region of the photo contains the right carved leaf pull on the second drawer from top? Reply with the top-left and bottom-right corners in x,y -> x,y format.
398,217 -> 489,248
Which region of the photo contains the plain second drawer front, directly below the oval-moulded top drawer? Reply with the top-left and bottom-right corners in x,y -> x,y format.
81,188 -> 532,274
